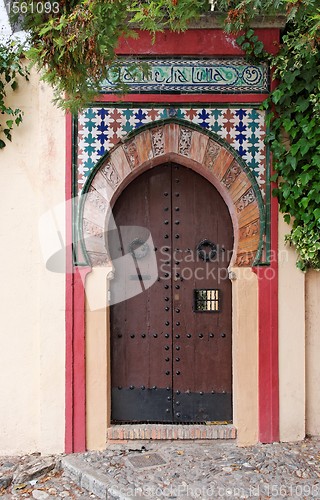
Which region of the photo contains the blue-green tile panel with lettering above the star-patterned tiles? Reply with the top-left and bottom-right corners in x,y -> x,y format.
102,57 -> 269,93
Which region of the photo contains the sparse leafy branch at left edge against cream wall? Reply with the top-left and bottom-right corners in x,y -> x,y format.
0,43 -> 28,149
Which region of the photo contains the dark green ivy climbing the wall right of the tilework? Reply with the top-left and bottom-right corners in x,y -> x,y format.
234,0 -> 320,271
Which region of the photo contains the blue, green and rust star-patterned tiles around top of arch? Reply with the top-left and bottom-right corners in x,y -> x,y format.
76,105 -> 266,196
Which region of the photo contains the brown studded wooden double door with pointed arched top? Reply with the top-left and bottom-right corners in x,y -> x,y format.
109,164 -> 233,423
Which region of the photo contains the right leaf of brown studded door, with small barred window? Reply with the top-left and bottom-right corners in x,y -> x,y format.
172,166 -> 233,422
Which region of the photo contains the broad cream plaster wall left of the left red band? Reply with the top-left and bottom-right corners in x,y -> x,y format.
0,66 -> 65,454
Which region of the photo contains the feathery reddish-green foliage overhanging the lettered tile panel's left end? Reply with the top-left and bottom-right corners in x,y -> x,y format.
18,0 -> 207,112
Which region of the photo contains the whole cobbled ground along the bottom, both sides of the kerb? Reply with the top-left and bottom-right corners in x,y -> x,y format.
0,438 -> 320,500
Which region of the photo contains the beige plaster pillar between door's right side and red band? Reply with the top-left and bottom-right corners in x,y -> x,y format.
232,267 -> 259,446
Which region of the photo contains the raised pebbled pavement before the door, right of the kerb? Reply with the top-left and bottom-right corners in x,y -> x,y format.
75,439 -> 320,499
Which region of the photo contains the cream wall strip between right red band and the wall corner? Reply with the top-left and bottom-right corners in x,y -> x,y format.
279,215 -> 305,441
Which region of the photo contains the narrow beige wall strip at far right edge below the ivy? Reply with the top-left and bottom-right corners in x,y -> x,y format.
306,271 -> 320,436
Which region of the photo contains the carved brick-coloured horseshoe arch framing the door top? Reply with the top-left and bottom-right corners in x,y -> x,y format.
79,120 -> 264,267
